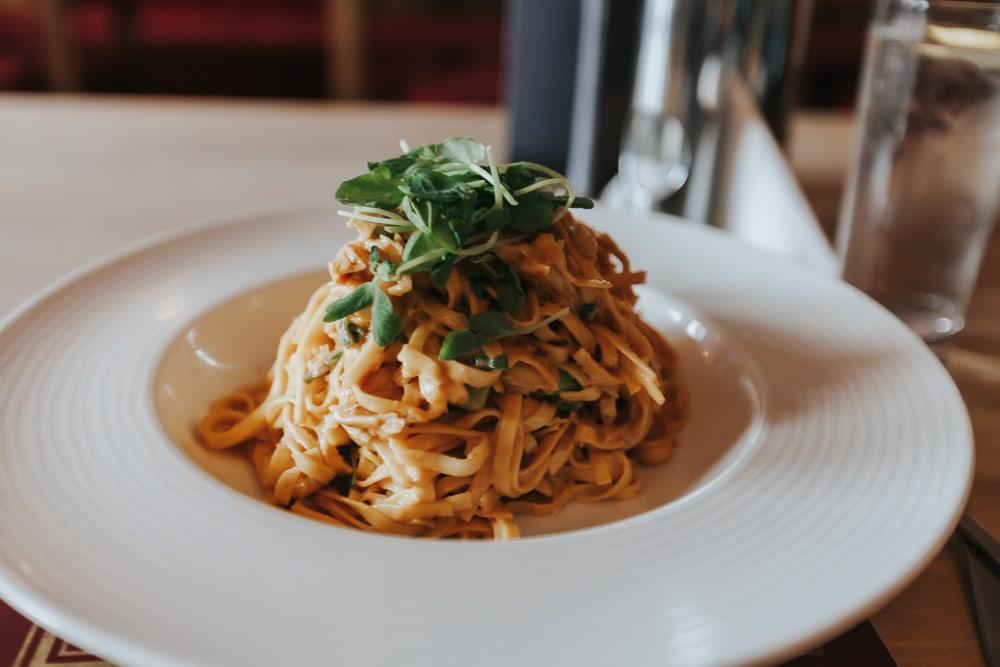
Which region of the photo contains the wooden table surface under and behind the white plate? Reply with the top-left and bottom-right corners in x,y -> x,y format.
0,96 -> 1000,665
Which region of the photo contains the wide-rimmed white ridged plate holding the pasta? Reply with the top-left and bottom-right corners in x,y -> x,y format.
0,204 -> 972,665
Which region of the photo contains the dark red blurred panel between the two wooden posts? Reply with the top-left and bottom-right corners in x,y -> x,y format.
68,0 -> 324,97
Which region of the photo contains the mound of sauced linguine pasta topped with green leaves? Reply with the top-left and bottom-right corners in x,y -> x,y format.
198,138 -> 686,539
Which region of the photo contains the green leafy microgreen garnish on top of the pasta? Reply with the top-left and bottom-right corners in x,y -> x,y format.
324,137 -> 594,358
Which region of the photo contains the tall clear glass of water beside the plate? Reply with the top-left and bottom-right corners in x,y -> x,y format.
838,0 -> 1000,343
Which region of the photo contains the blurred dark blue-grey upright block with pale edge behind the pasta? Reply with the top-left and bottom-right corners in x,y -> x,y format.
506,0 -> 642,177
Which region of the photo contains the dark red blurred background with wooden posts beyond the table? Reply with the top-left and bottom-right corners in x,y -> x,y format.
0,0 -> 871,108
